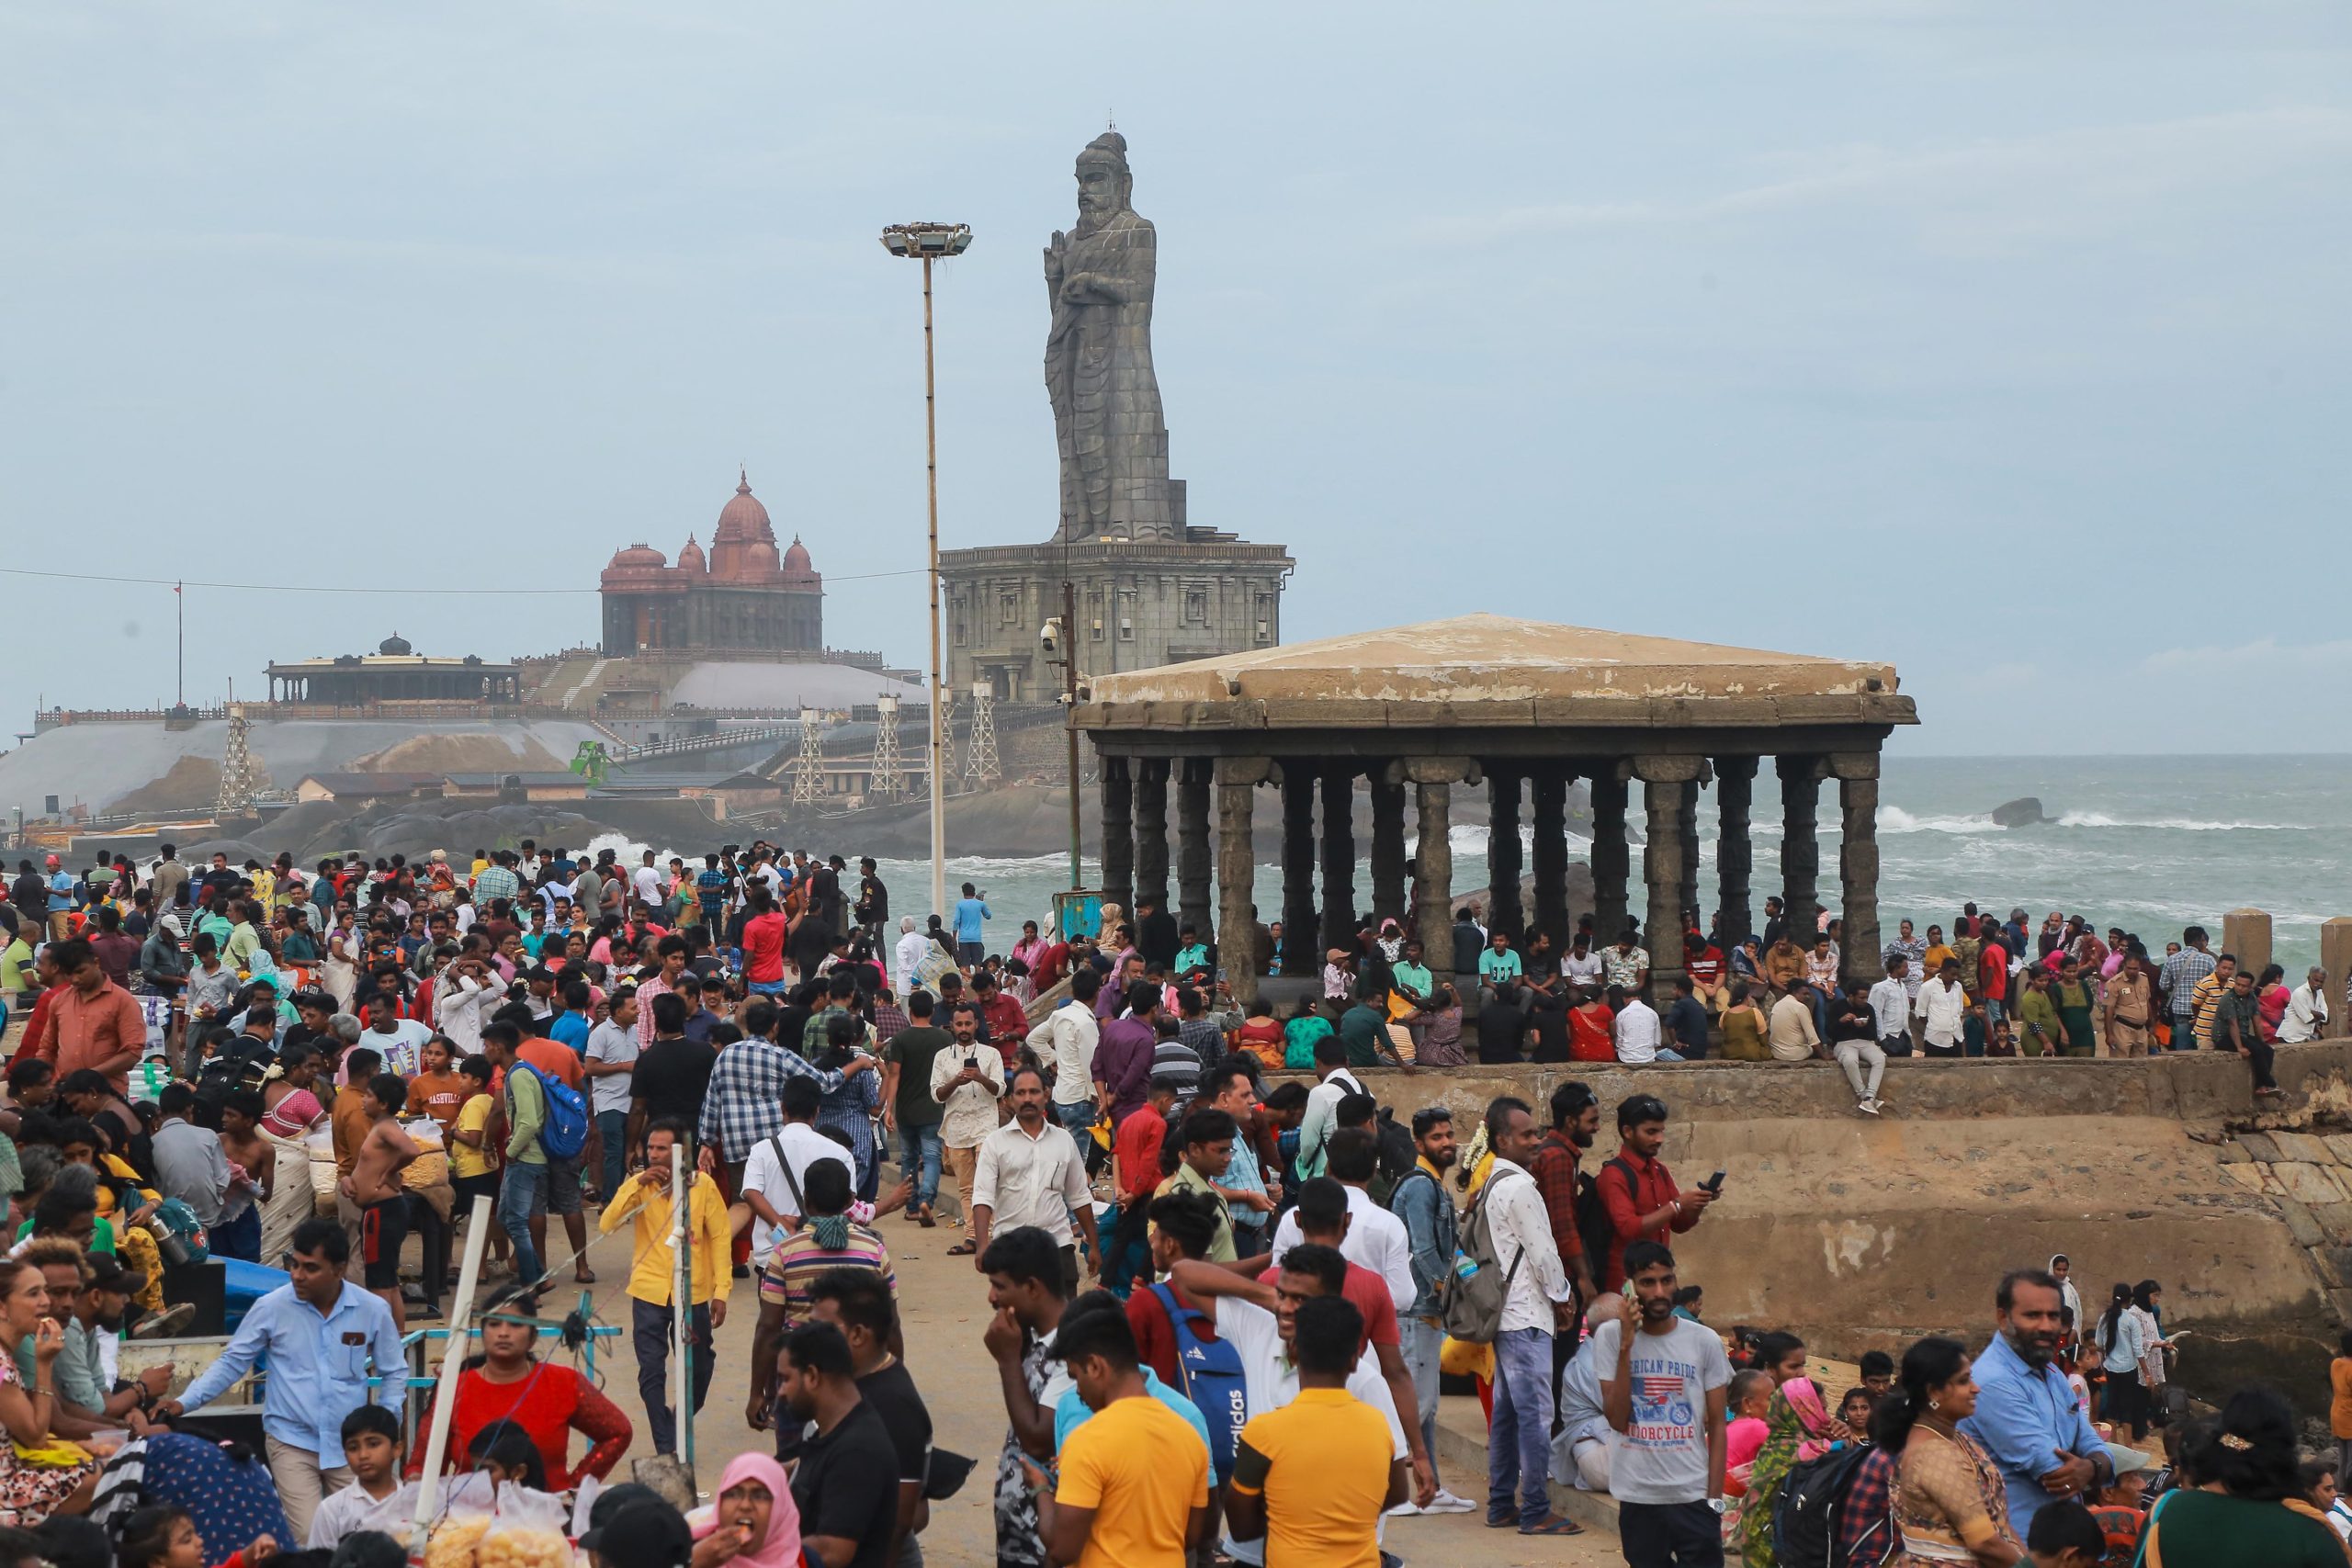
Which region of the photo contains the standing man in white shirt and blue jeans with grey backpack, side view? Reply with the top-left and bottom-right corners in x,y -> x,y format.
1465,1096 -> 1580,1535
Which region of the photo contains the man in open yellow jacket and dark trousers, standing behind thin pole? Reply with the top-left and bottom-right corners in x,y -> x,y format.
597,1122 -> 734,1453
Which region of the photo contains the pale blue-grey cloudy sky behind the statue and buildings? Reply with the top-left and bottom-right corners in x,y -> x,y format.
0,0 -> 2352,752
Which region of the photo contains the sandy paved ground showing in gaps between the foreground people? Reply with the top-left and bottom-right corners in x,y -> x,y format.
548,1189 -> 1623,1568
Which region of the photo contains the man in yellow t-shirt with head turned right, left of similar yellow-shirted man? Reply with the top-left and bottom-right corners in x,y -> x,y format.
1028,1291 -> 1211,1568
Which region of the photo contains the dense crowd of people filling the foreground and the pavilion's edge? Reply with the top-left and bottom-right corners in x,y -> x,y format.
0,844 -> 2352,1568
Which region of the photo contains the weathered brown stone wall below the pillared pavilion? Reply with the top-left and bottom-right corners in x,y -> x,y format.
1298,1042 -> 2352,1411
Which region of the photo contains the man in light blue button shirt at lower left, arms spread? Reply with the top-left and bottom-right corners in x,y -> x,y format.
155,1220 -> 409,1540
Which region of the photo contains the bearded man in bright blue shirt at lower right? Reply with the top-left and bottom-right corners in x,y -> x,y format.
1959,1269 -> 2114,1540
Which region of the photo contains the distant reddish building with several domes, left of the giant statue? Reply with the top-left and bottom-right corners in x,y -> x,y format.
602,475 -> 826,659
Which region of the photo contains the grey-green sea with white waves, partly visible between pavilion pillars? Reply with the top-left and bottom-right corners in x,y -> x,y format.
595,757 -> 2352,978
